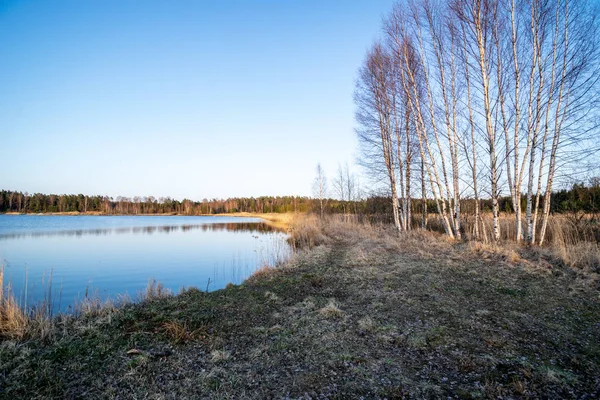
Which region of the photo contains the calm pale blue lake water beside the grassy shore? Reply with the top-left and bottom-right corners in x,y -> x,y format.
0,215 -> 289,311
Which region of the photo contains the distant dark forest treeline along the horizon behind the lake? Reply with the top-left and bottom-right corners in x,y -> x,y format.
0,178 -> 600,217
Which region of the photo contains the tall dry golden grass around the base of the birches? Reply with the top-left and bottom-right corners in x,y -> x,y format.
289,214 -> 600,274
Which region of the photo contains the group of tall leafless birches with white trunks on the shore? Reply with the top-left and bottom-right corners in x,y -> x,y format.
355,0 -> 600,244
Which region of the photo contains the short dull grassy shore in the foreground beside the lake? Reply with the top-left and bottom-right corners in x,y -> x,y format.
0,219 -> 600,399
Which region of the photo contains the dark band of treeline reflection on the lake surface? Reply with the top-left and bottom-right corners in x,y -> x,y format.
0,222 -> 279,239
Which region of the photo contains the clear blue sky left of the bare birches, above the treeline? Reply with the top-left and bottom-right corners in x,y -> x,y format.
0,0 -> 393,200
